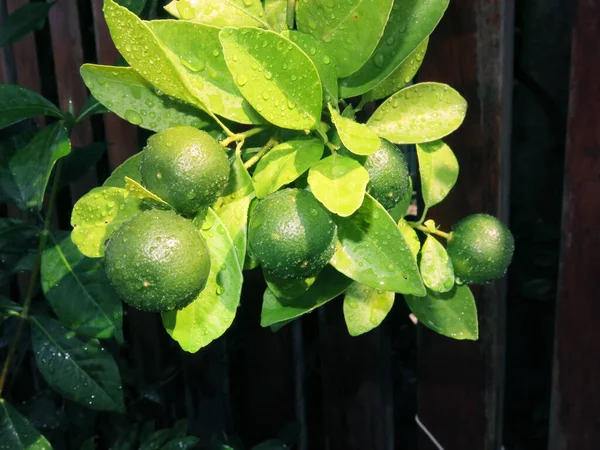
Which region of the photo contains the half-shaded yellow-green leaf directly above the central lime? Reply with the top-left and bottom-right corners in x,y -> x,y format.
253,137 -> 324,198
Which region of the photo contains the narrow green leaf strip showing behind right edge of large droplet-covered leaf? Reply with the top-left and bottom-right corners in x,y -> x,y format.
282,31 -> 338,104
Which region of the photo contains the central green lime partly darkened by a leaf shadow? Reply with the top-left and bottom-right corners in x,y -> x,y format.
248,189 -> 336,279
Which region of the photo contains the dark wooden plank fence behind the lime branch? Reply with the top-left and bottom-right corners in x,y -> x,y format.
0,0 -> 600,450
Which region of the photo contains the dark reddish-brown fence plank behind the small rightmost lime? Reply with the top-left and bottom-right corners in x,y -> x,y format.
418,0 -> 514,450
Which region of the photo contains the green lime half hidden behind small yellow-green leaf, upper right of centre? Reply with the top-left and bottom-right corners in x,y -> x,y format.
364,139 -> 411,210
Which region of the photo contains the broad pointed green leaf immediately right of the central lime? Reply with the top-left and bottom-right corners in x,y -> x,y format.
331,194 -> 425,295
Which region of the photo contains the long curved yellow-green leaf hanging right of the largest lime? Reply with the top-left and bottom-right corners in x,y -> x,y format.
162,209 -> 242,353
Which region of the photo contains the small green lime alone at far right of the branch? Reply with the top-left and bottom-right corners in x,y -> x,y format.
446,214 -> 515,284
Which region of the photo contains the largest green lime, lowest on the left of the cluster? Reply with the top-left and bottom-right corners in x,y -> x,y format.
105,209 -> 210,312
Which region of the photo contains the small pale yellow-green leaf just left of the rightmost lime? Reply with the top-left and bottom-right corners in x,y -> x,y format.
420,235 -> 454,292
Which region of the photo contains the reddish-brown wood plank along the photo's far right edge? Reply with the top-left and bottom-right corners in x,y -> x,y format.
549,0 -> 600,450
